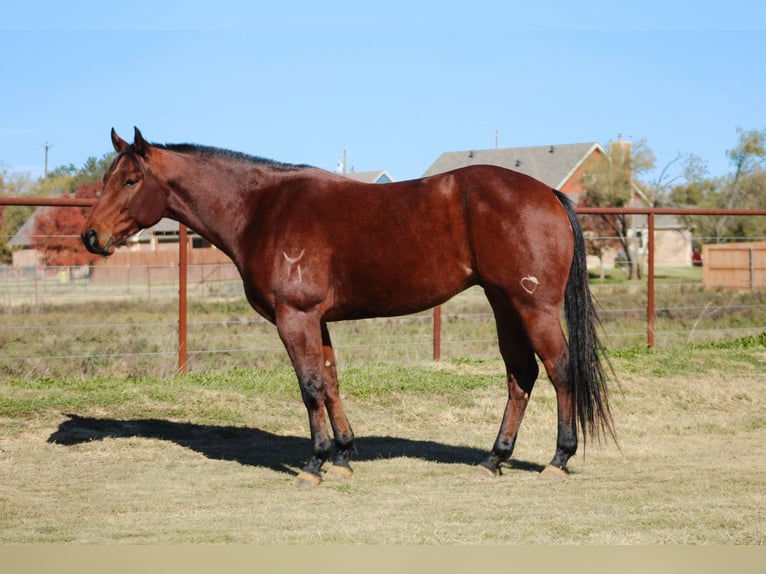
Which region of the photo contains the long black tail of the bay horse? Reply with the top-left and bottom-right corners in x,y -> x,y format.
554,190 -> 616,446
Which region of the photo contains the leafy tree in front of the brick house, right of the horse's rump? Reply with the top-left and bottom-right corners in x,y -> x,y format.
580,138 -> 654,279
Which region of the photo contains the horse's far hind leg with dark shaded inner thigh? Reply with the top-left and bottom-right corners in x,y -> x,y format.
479,289 -> 539,474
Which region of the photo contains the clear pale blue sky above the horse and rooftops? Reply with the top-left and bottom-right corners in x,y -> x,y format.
0,0 -> 766,186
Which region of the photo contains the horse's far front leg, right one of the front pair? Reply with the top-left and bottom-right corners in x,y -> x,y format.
322,323 -> 355,479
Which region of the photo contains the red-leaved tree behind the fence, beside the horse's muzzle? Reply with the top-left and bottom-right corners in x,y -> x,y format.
32,183 -> 101,267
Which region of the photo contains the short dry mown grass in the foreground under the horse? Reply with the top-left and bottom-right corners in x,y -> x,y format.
0,335 -> 766,545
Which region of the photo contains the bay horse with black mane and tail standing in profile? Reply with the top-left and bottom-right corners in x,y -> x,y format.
82,128 -> 614,484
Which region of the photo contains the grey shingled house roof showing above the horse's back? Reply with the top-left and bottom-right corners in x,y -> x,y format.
423,142 -> 606,189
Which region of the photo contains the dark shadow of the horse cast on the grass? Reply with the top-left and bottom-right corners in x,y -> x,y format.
48,414 -> 543,475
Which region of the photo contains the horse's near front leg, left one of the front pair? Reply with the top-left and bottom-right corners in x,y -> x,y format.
276,308 -> 332,485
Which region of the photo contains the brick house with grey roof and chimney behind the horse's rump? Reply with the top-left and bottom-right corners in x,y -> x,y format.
423,140 -> 692,268
